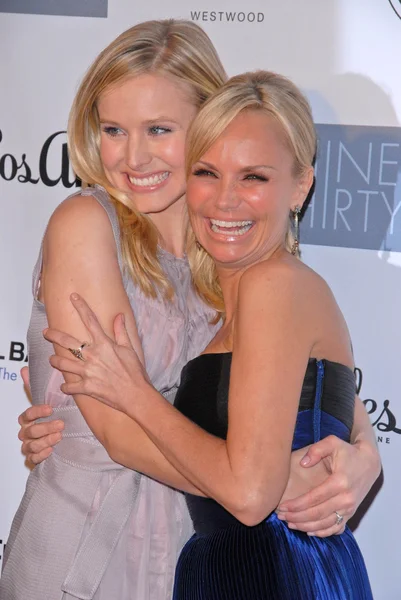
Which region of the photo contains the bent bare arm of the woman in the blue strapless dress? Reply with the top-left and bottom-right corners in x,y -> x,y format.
51,258 -> 312,525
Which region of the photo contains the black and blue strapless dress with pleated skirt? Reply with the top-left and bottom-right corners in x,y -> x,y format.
173,353 -> 373,600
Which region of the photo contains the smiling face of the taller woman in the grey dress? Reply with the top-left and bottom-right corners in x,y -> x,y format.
97,74 -> 197,214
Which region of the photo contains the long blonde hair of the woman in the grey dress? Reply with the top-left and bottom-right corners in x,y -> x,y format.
68,19 -> 226,297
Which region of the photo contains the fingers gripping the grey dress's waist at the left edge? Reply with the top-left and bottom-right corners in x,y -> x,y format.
18,367 -> 64,465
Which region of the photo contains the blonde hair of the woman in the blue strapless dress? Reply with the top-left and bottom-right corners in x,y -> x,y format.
186,71 -> 316,313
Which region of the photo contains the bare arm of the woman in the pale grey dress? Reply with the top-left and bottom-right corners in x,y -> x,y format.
40,196 -> 203,493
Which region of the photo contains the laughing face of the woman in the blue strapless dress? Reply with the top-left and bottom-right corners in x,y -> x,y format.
187,110 -> 313,269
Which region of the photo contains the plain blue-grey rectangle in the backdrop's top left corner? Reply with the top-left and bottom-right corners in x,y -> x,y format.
0,0 -> 108,17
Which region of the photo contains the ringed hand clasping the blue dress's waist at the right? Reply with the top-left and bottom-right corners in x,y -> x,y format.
277,435 -> 381,537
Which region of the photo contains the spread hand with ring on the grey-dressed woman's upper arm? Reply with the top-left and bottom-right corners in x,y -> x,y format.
44,294 -> 150,413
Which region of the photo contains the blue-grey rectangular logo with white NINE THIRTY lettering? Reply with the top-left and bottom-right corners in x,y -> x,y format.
301,125 -> 401,251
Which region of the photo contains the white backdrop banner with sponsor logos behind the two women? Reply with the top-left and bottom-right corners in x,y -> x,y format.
0,0 -> 401,600
